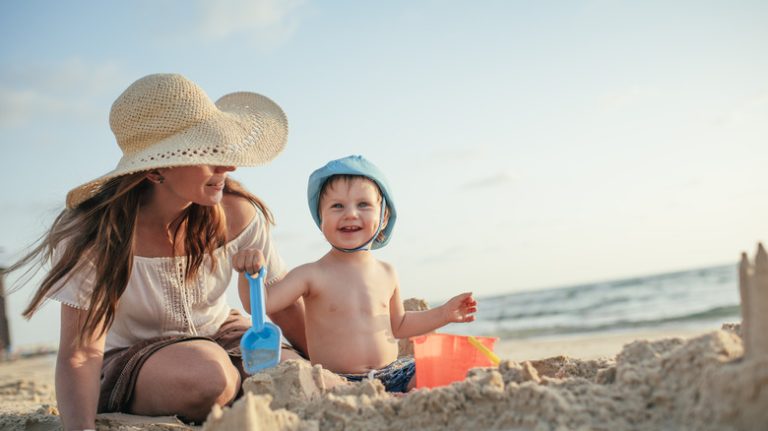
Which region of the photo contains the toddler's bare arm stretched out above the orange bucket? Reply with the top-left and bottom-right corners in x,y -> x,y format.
390,287 -> 477,338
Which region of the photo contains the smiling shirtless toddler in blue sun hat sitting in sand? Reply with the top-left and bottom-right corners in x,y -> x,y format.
266,156 -> 477,392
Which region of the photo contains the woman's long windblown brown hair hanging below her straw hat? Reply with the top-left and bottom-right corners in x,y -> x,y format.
5,172 -> 274,345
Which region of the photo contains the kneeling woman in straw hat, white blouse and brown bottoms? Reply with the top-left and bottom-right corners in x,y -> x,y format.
5,74 -> 305,430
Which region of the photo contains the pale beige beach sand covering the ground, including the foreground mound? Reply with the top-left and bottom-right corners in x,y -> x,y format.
0,330 -> 768,431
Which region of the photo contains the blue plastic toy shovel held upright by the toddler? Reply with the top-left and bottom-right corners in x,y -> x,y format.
240,266 -> 282,374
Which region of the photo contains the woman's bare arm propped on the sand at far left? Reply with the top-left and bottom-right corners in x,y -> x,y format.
56,304 -> 106,430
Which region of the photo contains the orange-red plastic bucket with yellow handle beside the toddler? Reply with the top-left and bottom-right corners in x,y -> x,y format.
411,334 -> 498,388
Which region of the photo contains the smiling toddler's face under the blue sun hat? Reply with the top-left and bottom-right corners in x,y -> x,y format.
320,178 -> 384,248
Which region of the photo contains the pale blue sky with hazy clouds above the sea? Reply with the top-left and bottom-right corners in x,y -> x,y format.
0,0 -> 768,350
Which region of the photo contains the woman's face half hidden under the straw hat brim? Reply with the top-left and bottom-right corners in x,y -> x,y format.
155,165 -> 235,206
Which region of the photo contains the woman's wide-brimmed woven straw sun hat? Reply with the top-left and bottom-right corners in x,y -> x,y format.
67,74 -> 288,208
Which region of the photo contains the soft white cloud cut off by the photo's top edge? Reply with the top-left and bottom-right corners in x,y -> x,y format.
200,0 -> 304,48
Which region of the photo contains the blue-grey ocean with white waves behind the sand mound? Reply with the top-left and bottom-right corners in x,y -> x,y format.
448,265 -> 741,339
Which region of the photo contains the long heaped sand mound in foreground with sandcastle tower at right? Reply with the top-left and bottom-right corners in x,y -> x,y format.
203,245 -> 768,431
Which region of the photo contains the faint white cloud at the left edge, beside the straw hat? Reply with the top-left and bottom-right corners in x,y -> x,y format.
0,59 -> 125,128
